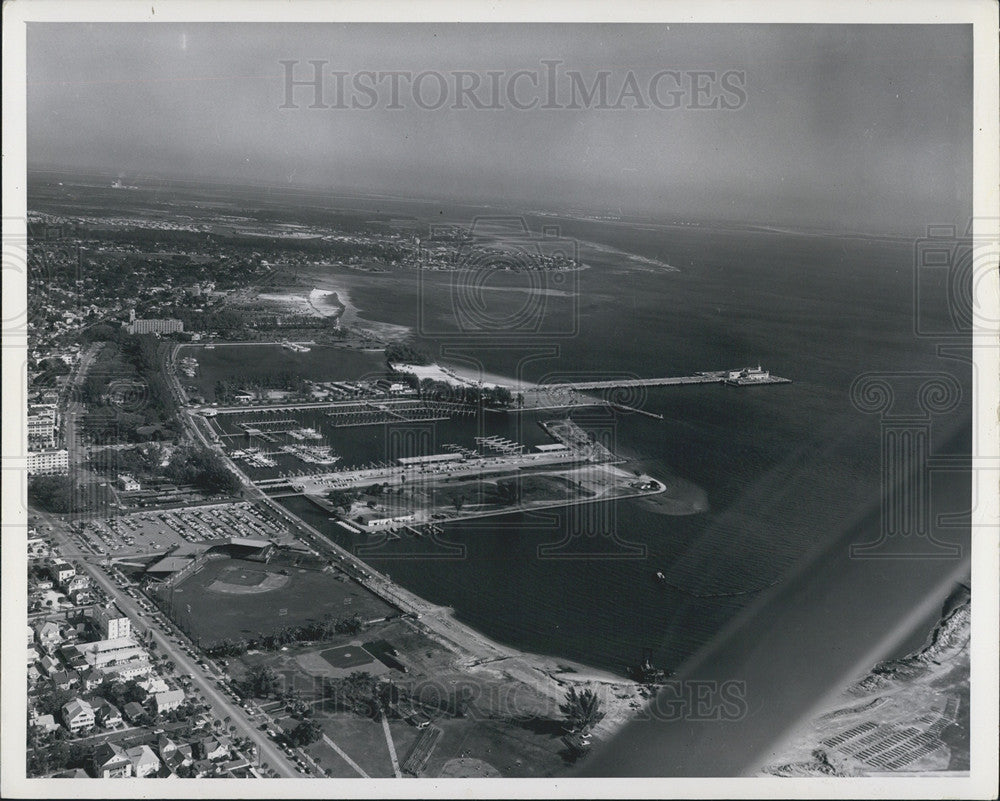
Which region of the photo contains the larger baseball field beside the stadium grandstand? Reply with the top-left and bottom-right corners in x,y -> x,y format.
173,559 -> 397,658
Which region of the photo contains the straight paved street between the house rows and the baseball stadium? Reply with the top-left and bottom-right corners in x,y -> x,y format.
41,514 -> 299,777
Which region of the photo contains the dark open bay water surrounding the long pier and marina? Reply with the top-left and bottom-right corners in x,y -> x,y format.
288,221 -> 971,673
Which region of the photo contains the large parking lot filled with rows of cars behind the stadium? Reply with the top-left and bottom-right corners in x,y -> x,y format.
74,502 -> 290,556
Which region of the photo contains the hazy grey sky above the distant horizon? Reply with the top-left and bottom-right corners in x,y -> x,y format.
28,23 -> 972,230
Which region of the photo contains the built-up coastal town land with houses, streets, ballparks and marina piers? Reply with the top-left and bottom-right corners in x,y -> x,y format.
19,195 -> 684,778
